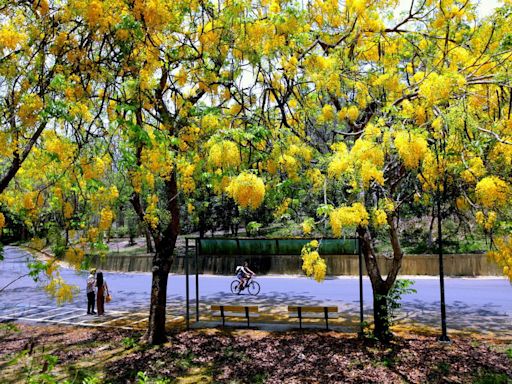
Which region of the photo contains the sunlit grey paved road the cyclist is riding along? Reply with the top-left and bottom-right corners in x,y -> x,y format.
0,247 -> 512,335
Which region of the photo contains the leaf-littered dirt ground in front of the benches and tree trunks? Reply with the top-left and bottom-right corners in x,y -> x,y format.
0,323 -> 512,384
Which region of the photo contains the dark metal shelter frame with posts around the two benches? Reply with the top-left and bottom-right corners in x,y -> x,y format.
184,237 -> 364,334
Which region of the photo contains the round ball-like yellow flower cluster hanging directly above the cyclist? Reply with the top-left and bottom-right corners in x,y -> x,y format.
227,172 -> 265,209
